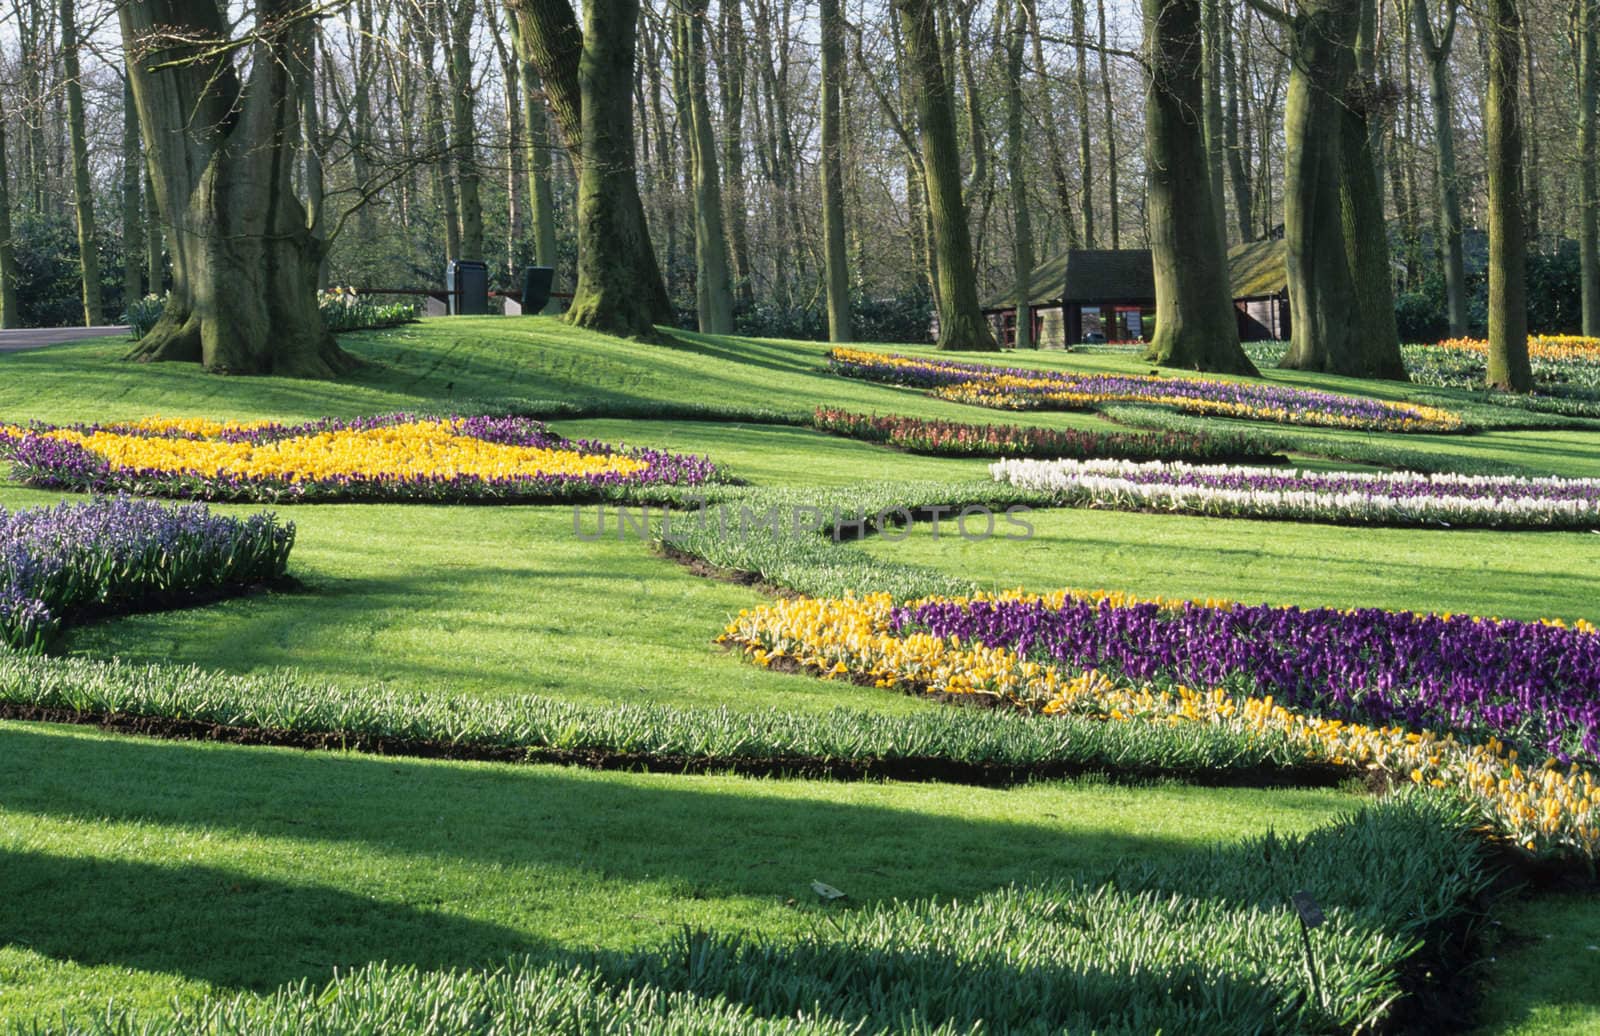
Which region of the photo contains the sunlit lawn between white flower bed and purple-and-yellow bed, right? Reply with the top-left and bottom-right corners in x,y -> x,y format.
861,510 -> 1600,619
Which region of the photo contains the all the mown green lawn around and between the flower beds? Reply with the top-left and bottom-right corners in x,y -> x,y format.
0,318 -> 1600,1033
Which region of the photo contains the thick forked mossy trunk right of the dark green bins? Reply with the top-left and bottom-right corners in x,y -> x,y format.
507,0 -> 674,327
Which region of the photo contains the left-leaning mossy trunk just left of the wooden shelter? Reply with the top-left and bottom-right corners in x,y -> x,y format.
894,0 -> 998,350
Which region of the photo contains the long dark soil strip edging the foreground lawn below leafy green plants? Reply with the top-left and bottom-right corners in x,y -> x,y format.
0,702 -> 1350,788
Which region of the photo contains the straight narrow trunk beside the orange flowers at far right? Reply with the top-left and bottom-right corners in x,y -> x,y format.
1485,0 -> 1533,392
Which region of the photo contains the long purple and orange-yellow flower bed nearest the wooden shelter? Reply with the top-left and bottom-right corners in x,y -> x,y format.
827,349 -> 1462,432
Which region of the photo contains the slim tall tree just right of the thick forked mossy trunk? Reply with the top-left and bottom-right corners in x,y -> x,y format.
678,0 -> 733,334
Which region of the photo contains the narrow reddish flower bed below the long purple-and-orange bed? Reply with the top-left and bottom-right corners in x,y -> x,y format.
811,406 -> 1277,460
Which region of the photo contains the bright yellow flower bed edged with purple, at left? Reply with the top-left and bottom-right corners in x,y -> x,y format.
0,414 -> 718,502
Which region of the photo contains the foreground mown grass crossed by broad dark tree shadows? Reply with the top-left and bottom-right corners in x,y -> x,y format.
0,723 -> 1350,1020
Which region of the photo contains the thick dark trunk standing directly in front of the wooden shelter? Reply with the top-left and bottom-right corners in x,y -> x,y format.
1144,0 -> 1256,374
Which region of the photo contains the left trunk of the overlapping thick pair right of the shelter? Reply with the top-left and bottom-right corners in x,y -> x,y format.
1280,0 -> 1365,376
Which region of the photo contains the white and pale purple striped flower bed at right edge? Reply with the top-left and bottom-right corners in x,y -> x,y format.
989,460 -> 1600,529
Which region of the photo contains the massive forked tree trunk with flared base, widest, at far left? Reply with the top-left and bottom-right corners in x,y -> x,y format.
118,0 -> 355,377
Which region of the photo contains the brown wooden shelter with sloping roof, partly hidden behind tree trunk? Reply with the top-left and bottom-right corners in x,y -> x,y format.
984,238 -> 1290,349
